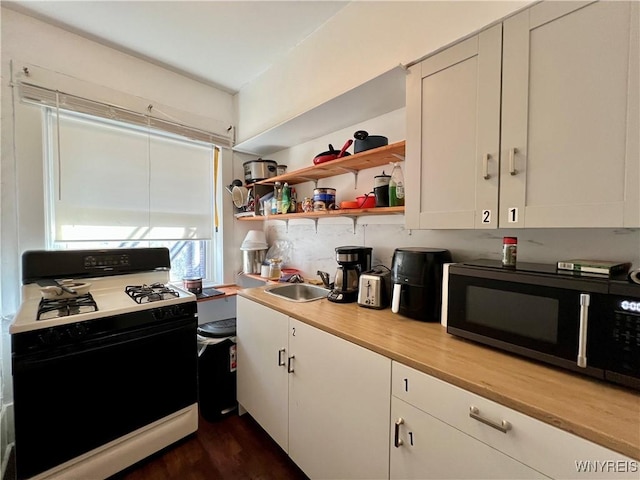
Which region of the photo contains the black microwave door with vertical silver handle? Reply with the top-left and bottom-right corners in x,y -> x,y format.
447,265 -> 607,378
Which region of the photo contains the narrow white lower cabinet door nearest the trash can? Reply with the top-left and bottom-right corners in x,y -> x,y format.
236,297 -> 289,451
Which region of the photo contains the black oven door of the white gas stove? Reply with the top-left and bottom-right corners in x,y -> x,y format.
13,317 -> 197,479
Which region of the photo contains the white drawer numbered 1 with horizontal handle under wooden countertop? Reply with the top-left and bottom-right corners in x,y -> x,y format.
391,362 -> 639,479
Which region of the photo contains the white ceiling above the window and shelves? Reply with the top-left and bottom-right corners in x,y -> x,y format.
2,0 -> 349,93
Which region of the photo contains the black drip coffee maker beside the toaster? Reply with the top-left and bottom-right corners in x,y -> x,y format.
327,246 -> 373,303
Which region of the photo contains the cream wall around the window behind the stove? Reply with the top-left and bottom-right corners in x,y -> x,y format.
1,8 -> 240,313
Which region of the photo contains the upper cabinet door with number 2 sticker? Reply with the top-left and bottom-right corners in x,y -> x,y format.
405,25 -> 502,228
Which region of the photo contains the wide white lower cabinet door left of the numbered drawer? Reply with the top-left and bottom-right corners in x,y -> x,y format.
289,319 -> 391,479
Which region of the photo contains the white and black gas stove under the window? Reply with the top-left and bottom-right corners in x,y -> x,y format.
9,248 -> 198,480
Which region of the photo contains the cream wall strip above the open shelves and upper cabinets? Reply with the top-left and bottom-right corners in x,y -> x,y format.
236,1 -> 532,141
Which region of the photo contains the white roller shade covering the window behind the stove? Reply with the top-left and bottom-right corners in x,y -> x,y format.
47,109 -> 215,242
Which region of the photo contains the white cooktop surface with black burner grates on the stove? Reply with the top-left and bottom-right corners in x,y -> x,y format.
9,271 -> 196,334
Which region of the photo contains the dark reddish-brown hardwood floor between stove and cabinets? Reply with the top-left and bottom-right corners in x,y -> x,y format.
110,414 -> 308,480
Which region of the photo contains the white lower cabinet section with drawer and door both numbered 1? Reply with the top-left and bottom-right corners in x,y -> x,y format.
390,362 -> 640,480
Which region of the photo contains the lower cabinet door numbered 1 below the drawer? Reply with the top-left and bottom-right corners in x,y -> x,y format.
390,397 -> 549,480
